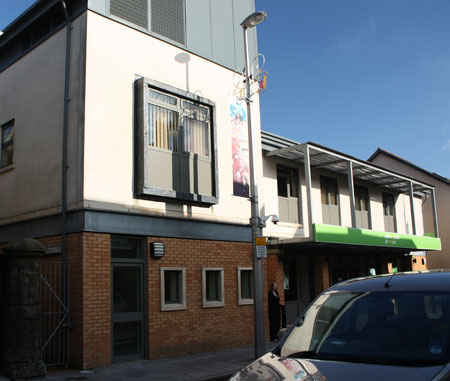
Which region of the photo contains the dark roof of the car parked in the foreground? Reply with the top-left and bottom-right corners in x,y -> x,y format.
327,270 -> 450,292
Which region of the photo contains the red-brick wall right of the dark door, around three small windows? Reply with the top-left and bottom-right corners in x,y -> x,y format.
148,238 -> 267,358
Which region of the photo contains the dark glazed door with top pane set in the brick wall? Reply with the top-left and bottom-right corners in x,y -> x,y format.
111,237 -> 145,362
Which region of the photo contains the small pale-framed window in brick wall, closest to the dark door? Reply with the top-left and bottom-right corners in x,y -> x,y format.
160,267 -> 186,311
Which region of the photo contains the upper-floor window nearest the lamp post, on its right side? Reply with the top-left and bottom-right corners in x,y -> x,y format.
277,165 -> 300,224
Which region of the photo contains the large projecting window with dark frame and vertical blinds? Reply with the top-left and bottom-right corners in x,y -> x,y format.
135,78 -> 218,206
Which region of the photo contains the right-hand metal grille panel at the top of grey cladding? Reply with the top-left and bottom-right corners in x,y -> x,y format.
151,0 -> 185,44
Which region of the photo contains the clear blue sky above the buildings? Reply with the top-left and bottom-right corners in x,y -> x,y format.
0,0 -> 450,178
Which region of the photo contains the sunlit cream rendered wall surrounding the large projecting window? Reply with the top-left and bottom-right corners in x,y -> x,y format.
84,12 -> 262,224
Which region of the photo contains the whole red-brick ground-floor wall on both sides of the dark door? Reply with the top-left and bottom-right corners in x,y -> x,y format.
33,233 -> 273,369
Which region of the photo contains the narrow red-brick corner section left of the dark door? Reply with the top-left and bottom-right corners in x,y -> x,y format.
38,233 -> 111,369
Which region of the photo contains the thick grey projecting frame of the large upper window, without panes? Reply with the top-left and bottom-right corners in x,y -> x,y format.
134,77 -> 219,206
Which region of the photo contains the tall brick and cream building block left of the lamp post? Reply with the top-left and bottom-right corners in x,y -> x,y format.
0,0 -> 267,368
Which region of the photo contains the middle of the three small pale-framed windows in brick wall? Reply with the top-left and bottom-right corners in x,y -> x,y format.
202,267 -> 225,308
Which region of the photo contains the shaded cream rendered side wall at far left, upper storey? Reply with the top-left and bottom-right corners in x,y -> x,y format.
0,15 -> 85,225
